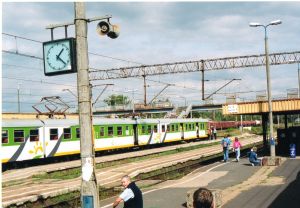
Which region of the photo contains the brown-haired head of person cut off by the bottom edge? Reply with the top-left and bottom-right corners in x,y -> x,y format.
193,188 -> 214,208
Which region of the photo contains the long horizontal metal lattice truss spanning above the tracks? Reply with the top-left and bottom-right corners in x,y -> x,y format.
90,51 -> 300,81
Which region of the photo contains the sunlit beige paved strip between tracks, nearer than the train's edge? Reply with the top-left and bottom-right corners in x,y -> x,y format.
2,136 -> 262,207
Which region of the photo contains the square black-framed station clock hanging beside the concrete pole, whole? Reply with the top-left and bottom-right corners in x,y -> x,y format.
43,38 -> 77,76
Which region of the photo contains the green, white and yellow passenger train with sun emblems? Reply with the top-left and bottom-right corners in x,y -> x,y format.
1,118 -> 208,164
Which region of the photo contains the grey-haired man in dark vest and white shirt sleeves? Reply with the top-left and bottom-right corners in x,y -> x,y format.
113,175 -> 143,208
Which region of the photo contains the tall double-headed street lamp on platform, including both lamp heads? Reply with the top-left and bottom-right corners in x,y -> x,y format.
249,20 -> 282,157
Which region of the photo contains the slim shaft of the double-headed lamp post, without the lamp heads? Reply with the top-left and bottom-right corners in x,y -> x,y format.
264,26 -> 275,157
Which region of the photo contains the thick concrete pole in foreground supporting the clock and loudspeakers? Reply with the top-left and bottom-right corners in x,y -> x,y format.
74,2 -> 100,208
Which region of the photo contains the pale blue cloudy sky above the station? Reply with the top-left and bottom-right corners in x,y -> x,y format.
1,1 -> 300,112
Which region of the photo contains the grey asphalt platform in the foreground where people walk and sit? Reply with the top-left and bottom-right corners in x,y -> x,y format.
101,157 -> 300,208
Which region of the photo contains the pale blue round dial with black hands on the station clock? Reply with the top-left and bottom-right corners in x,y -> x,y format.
46,43 -> 71,71
